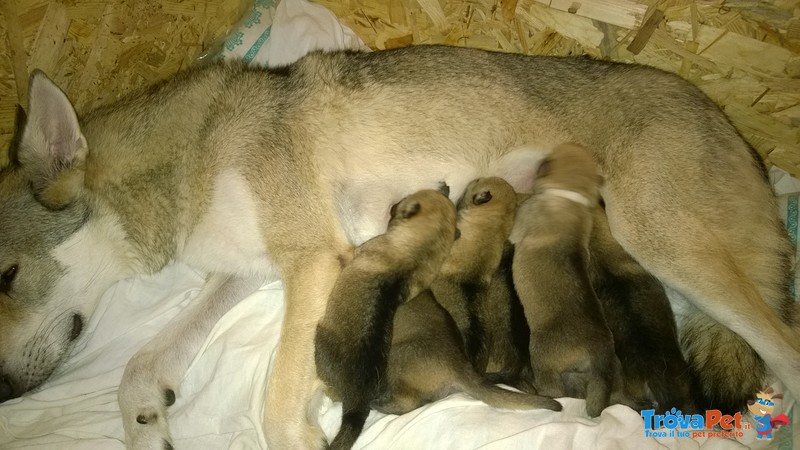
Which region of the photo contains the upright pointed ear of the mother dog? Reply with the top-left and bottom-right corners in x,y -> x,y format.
15,70 -> 88,209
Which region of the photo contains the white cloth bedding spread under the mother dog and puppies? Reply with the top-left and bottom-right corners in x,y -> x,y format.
0,0 -> 800,450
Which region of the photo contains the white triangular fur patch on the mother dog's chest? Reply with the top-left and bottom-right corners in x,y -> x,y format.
178,170 -> 277,280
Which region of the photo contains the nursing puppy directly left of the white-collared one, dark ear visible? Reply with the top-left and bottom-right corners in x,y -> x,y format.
431,177 -> 527,386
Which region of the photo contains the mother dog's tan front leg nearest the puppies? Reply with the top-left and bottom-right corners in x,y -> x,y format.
264,251 -> 341,449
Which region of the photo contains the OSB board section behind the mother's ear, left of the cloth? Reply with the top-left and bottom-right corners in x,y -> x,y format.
0,0 -> 249,164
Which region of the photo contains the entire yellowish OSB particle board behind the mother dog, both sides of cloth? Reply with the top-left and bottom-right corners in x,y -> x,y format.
0,0 -> 800,175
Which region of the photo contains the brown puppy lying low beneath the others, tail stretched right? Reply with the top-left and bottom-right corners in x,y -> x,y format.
372,291 -> 561,414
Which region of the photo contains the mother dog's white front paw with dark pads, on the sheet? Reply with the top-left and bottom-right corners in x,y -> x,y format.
118,357 -> 175,450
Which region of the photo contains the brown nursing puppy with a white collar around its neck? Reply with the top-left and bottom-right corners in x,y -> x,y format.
511,144 -> 619,417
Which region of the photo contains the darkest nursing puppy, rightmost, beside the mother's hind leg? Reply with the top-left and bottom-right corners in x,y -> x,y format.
589,208 -> 697,414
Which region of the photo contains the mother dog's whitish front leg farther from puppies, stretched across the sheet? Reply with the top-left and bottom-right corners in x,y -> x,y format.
118,274 -> 262,449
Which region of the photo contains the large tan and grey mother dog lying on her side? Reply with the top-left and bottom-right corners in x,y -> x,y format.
0,47 -> 800,448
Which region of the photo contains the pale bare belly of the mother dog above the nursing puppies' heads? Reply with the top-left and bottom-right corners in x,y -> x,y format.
338,146 -> 549,245
